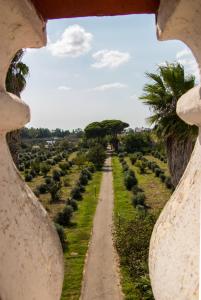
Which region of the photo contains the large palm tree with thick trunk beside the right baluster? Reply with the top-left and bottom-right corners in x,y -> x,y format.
140,63 -> 197,187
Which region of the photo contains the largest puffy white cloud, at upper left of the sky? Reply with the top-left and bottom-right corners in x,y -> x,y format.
48,24 -> 93,57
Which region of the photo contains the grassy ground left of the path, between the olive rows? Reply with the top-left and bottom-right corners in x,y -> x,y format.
21,153 -> 102,300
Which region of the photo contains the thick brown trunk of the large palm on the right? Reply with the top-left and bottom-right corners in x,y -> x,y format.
166,136 -> 195,187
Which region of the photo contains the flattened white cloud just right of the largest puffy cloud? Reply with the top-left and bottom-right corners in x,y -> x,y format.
92,49 -> 130,69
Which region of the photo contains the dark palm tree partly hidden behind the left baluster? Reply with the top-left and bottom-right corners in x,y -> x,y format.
6,50 -> 29,164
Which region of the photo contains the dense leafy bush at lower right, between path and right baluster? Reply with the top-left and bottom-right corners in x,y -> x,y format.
115,214 -> 155,300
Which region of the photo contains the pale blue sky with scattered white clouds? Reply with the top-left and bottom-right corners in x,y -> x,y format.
22,15 -> 198,130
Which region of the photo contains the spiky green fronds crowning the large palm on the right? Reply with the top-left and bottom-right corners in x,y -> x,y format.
140,63 -> 197,138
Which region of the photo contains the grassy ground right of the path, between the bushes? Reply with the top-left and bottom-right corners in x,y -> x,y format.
112,157 -> 171,300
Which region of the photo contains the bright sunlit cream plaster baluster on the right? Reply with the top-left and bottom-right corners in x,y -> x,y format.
149,0 -> 201,300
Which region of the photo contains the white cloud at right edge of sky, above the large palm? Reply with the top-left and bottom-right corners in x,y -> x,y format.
176,48 -> 200,81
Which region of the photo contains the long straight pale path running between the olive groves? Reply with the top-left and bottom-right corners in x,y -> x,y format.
81,157 -> 123,300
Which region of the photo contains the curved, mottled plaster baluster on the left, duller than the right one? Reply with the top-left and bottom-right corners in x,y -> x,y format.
0,0 -> 63,300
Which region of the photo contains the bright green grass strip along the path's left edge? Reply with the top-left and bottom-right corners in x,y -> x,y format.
61,172 -> 102,300
